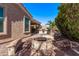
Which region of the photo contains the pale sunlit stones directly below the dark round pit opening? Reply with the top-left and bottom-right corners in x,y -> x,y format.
31,37 -> 55,56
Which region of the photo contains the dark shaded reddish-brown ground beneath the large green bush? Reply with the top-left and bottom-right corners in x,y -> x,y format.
53,33 -> 79,56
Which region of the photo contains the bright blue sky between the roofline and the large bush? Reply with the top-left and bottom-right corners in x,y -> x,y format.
23,3 -> 60,24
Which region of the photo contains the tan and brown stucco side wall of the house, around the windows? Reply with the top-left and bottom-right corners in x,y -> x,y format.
0,3 -> 31,43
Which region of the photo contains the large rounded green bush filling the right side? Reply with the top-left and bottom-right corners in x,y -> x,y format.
55,3 -> 79,40
